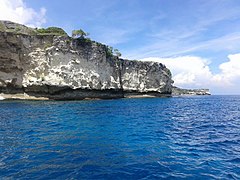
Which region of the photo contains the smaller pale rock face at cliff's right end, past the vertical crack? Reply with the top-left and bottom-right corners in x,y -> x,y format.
122,60 -> 172,93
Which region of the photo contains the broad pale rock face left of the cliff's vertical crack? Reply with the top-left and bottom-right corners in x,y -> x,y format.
23,37 -> 121,90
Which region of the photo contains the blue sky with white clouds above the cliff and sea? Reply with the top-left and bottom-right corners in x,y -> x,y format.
0,0 -> 240,94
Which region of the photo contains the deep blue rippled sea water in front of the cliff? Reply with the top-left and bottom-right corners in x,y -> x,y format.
0,96 -> 240,179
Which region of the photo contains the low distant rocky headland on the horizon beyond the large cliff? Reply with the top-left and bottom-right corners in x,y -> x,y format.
172,86 -> 211,96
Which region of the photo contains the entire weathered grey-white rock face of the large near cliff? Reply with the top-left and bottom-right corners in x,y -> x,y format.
0,22 -> 172,99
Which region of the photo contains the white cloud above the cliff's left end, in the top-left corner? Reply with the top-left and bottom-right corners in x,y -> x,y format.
0,0 -> 46,27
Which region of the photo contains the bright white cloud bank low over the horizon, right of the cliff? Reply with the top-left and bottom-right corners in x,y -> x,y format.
142,53 -> 240,94
